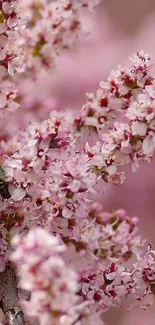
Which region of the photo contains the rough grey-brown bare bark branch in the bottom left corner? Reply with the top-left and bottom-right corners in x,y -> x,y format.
0,265 -> 24,325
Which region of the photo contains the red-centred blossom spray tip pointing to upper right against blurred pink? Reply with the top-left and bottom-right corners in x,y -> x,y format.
75,51 -> 154,134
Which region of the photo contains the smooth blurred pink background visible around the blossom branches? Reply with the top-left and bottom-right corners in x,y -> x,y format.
13,0 -> 155,325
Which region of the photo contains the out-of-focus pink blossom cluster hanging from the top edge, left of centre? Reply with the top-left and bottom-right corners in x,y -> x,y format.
23,0 -> 101,73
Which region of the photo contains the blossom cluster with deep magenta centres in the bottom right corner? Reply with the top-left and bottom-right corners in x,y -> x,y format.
81,249 -> 155,312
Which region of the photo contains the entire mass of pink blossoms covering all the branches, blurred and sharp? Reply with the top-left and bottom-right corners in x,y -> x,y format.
0,0 -> 155,325
